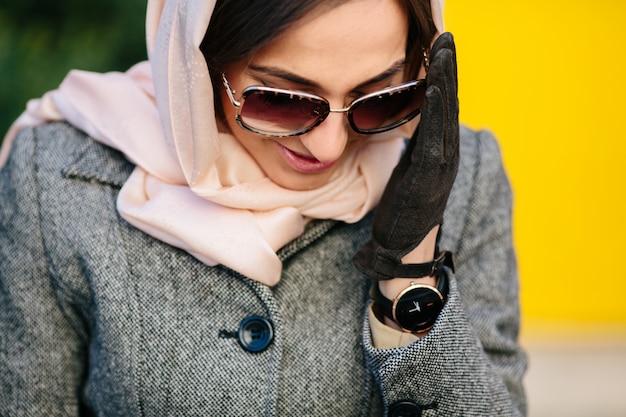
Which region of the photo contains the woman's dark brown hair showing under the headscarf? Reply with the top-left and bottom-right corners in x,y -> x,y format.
200,0 -> 436,118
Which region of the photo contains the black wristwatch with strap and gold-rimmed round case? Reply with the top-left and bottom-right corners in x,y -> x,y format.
371,271 -> 449,333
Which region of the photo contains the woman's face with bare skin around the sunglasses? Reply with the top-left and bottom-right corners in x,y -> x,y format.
221,0 -> 407,190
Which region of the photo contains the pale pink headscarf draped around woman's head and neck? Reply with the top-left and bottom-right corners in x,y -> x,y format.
0,0 -> 403,285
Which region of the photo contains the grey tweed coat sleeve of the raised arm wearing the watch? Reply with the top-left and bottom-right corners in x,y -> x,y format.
363,128 -> 526,416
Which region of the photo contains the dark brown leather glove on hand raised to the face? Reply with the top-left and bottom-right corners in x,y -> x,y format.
353,33 -> 459,280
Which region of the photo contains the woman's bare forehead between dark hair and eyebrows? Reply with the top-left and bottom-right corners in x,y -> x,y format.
241,0 -> 408,90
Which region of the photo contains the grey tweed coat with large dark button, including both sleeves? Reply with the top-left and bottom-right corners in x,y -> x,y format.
0,123 -> 526,417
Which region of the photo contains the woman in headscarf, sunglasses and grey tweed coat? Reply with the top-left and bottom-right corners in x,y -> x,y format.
0,0 -> 525,416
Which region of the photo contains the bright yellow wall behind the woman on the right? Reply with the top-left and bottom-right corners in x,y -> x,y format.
444,0 -> 626,330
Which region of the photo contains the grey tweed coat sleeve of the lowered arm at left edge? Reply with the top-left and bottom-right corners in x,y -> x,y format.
0,129 -> 86,417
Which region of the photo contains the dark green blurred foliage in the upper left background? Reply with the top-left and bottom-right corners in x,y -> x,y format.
0,0 -> 146,141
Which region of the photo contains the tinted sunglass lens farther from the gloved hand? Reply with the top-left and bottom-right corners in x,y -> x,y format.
240,91 -> 328,135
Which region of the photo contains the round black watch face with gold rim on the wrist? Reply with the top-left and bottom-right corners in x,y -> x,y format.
392,284 -> 444,333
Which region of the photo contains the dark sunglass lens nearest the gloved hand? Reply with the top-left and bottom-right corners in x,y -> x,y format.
351,82 -> 426,133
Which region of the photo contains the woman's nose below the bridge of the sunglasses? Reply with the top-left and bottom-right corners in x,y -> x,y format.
300,113 -> 350,162
